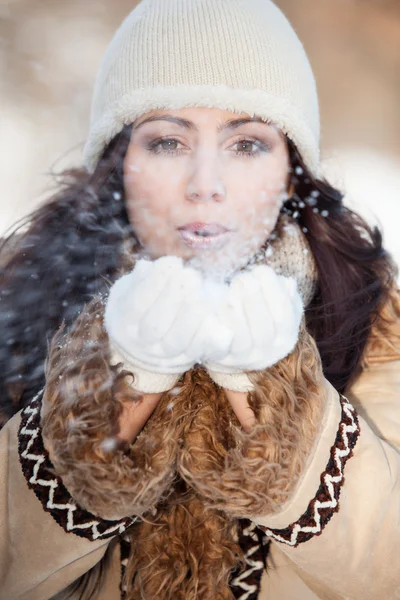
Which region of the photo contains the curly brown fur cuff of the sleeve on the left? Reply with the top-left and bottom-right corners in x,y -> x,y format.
42,299 -> 179,520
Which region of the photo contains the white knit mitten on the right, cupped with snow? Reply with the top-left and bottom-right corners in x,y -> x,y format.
204,265 -> 303,391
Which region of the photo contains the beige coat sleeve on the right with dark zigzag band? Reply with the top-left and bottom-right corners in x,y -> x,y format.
252,294 -> 400,600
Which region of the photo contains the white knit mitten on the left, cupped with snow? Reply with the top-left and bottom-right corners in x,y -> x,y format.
105,256 -> 216,393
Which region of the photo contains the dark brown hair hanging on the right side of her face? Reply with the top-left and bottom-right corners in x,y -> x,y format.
283,142 -> 397,392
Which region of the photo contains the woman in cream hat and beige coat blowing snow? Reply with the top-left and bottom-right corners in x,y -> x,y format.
0,0 -> 400,600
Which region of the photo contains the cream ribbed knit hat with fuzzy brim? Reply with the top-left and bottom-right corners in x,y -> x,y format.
84,0 -> 319,174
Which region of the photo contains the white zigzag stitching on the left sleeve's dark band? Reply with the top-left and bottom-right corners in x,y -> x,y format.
21,392 -> 135,540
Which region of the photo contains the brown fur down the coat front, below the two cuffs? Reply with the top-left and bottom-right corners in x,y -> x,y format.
125,488 -> 241,600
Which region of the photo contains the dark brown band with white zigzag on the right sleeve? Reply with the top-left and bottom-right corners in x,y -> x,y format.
259,395 -> 360,547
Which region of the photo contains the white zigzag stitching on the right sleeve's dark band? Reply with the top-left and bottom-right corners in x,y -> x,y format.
265,399 -> 357,546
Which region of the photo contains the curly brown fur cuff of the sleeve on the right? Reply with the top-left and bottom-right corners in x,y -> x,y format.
178,327 -> 326,519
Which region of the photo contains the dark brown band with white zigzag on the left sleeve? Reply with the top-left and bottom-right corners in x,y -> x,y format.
18,390 -> 136,541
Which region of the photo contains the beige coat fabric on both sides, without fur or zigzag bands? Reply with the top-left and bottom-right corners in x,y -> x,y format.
0,288 -> 400,600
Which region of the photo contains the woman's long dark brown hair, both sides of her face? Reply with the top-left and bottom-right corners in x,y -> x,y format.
0,126 -> 394,422
